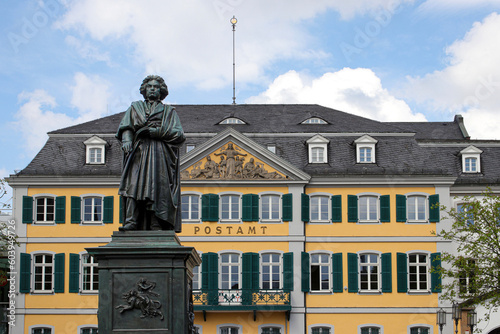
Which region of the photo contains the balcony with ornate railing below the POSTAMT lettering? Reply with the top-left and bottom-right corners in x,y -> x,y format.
193,289 -> 292,311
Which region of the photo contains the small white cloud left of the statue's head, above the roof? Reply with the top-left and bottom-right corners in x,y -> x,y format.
15,73 -> 108,153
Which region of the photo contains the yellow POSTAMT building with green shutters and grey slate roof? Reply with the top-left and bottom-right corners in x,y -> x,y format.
8,105 -> 500,334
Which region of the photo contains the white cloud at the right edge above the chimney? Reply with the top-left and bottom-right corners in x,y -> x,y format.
405,13 -> 500,138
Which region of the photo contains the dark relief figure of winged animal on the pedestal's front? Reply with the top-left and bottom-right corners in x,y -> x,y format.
116,278 -> 163,320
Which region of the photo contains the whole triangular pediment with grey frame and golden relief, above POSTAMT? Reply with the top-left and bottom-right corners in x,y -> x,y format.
181,128 -> 310,182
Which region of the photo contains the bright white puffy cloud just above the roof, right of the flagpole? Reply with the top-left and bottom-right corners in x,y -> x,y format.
246,68 -> 425,121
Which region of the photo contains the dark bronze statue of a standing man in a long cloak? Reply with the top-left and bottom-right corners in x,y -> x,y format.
116,75 -> 185,232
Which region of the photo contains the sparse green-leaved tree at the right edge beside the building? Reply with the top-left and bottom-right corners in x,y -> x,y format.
437,189 -> 500,320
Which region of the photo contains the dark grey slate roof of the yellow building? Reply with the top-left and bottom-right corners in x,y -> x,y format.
18,104 -> 500,184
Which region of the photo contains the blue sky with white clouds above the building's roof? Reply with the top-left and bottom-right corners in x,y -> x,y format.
0,0 -> 500,190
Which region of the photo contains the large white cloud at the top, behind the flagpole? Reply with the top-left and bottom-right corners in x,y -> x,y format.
56,0 -> 414,89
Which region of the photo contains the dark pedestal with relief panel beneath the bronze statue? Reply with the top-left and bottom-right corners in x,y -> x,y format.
87,231 -> 201,334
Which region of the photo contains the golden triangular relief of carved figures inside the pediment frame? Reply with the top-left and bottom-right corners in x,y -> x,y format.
181,142 -> 287,180
